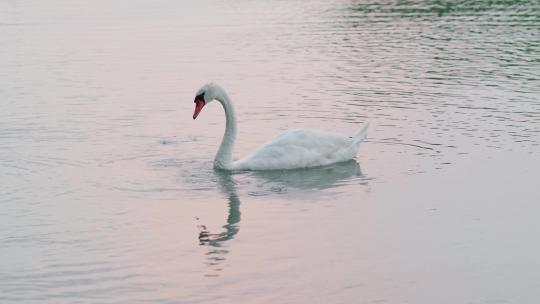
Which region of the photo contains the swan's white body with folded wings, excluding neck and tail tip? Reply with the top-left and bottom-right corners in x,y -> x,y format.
234,129 -> 358,170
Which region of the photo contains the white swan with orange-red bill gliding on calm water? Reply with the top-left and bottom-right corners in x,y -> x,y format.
193,83 -> 368,170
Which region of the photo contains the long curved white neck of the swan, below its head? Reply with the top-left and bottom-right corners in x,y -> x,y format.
214,89 -> 236,169
